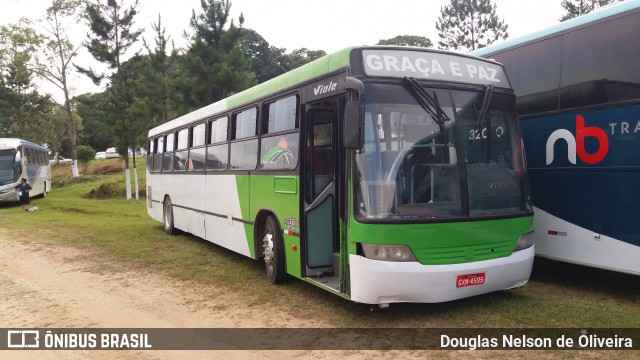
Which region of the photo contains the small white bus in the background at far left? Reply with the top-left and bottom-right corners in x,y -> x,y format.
0,138 -> 51,202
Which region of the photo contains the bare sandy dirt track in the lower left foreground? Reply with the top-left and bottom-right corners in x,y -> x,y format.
0,229 -> 440,359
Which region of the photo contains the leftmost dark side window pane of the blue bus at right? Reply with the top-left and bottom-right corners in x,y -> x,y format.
491,36 -> 562,115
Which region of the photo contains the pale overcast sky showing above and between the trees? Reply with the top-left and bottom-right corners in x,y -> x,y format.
0,0 -> 563,94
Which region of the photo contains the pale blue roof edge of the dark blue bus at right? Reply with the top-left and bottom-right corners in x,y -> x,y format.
471,0 -> 640,56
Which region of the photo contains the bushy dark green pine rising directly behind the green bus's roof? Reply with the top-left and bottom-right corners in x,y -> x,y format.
179,0 -> 256,111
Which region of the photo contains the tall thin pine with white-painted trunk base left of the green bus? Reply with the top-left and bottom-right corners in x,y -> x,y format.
76,0 -> 143,199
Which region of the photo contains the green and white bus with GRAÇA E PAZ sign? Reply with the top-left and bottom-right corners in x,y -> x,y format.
147,46 -> 534,305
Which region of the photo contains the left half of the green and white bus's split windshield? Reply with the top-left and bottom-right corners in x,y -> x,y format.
356,84 -> 462,221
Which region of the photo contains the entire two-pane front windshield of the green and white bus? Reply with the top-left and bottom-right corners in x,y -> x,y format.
356,83 -> 531,221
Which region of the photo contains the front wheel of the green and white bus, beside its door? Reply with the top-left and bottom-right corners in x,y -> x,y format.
262,216 -> 286,284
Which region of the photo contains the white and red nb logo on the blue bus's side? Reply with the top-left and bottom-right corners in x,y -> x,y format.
546,115 -> 609,165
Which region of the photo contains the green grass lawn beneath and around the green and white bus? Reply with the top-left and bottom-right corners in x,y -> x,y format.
0,160 -> 640,328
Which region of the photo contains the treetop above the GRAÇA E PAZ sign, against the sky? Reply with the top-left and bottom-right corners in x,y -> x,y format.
436,0 -> 509,51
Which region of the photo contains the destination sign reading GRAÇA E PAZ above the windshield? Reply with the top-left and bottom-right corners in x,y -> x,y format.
362,49 -> 511,88
